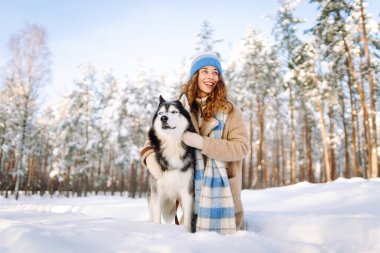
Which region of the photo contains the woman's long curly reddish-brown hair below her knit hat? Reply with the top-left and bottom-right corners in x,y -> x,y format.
181,71 -> 233,121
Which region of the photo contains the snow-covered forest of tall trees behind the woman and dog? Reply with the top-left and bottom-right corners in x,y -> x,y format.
0,0 -> 380,199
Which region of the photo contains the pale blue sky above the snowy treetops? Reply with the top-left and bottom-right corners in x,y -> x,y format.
0,0 -> 380,103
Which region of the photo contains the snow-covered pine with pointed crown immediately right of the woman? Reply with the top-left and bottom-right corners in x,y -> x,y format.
226,28 -> 280,188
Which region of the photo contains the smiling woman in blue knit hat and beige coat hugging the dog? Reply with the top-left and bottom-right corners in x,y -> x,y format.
141,53 -> 248,234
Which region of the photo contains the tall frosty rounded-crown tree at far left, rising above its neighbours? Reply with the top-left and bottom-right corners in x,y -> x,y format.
5,25 -> 50,199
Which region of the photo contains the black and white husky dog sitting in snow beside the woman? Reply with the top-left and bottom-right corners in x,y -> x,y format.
149,94 -> 195,231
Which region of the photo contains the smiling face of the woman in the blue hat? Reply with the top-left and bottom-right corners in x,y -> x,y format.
198,66 -> 219,98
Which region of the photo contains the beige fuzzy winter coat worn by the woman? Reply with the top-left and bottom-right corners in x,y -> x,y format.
141,102 -> 248,230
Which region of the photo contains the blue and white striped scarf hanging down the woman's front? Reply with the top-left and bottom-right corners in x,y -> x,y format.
194,112 -> 236,234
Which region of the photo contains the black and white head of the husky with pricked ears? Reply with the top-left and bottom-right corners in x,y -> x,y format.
153,94 -> 192,135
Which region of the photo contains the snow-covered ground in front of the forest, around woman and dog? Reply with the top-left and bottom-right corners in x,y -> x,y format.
0,178 -> 380,253
